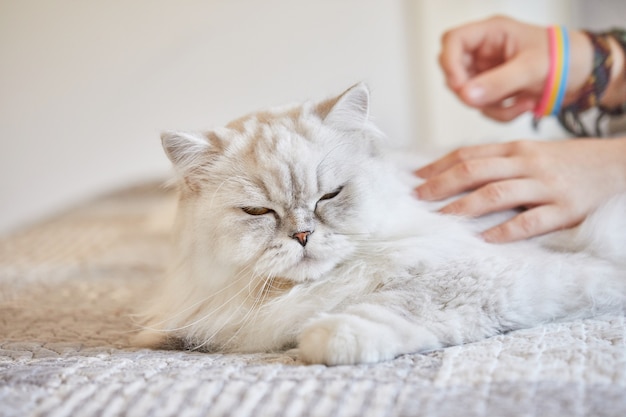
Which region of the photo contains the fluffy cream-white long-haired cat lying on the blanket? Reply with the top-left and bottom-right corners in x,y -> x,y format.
137,84 -> 626,365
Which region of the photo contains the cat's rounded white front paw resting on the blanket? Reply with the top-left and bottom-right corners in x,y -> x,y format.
299,314 -> 399,365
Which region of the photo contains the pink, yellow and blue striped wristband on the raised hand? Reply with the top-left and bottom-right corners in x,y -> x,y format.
533,26 -> 570,127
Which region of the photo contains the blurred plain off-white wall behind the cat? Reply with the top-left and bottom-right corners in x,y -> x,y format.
0,0 -> 626,234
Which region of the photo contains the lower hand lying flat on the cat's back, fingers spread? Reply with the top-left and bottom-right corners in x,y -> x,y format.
416,137 -> 626,243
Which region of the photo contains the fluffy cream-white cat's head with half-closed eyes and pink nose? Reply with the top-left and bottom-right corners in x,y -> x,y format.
162,84 -> 382,282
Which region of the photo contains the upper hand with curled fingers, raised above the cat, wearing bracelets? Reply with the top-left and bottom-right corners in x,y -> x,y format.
439,16 -> 593,121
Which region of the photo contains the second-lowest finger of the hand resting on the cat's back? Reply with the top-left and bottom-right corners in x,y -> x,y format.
439,178 -> 550,217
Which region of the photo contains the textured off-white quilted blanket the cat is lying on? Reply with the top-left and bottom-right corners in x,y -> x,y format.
0,187 -> 626,417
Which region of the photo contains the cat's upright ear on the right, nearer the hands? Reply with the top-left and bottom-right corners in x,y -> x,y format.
315,83 -> 370,130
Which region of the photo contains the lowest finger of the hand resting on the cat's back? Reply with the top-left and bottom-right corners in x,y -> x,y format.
481,205 -> 576,243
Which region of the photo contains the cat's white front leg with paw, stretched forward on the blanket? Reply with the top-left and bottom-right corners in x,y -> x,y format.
299,304 -> 441,365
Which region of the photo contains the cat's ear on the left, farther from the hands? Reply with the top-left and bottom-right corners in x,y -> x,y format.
161,131 -> 223,186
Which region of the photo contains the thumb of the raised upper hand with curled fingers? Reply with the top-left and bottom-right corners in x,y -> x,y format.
459,55 -> 548,108
